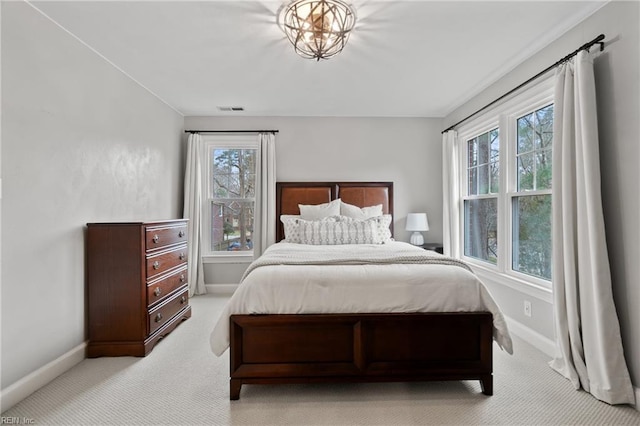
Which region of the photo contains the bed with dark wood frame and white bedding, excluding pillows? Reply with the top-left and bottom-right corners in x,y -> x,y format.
210,182 -> 512,400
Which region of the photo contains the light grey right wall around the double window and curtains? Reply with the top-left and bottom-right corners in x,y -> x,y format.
444,1 -> 640,388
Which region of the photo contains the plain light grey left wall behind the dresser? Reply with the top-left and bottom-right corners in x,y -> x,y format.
1,2 -> 184,390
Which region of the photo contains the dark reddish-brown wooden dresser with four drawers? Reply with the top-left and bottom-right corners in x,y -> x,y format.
87,219 -> 191,358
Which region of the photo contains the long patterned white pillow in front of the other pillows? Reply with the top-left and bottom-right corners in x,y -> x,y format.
299,216 -> 382,245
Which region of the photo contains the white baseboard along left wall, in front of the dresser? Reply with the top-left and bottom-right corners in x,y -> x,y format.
0,342 -> 87,412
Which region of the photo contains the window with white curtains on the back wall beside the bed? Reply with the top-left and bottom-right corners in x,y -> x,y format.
203,135 -> 260,256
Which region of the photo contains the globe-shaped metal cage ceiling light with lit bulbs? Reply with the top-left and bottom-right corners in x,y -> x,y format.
280,0 -> 356,61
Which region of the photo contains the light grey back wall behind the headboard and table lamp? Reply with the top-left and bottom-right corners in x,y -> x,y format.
185,117 -> 442,284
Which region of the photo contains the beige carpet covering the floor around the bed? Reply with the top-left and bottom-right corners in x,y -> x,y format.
2,295 -> 640,425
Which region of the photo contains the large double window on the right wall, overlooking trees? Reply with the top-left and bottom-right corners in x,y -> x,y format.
458,79 -> 553,288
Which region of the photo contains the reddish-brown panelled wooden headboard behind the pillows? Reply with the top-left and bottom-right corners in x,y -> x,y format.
276,182 -> 393,242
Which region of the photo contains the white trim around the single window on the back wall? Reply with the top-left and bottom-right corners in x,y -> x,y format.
202,135 -> 261,263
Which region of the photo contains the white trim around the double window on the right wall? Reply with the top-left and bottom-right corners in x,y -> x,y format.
458,73 -> 554,292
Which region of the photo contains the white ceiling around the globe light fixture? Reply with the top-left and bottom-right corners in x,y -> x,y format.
31,0 -> 606,117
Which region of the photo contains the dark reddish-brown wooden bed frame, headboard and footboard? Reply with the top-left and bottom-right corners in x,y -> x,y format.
230,182 -> 493,400
